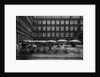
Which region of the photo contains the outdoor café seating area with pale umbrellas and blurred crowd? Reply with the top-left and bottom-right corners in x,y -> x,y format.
16,40 -> 83,57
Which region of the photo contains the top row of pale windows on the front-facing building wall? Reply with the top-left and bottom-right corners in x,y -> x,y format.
34,20 -> 83,25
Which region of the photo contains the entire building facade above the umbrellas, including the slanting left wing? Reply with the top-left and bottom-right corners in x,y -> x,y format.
16,16 -> 83,43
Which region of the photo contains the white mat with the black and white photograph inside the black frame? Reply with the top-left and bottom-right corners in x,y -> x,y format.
4,5 -> 96,73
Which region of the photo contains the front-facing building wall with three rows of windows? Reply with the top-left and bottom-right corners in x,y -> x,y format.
33,16 -> 83,40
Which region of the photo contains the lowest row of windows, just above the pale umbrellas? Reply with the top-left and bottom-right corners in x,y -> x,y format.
33,32 -> 74,37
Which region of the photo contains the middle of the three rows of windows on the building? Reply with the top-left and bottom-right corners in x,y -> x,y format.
34,26 -> 83,31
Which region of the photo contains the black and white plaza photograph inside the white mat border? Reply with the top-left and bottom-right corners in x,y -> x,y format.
16,16 -> 84,60
